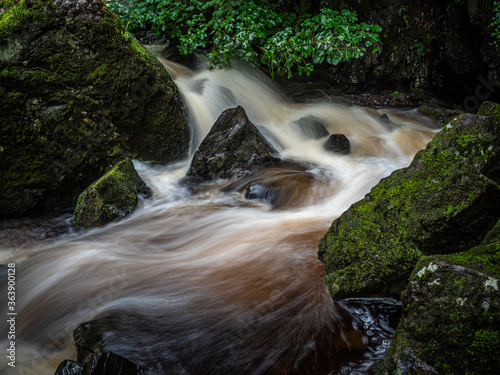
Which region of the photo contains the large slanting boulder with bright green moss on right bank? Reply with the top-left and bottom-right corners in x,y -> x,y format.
318,105 -> 500,297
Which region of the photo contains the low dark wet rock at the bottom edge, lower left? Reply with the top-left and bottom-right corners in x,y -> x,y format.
55,352 -> 148,375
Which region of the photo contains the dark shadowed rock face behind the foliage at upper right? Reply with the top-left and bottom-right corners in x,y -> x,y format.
327,0 -> 500,103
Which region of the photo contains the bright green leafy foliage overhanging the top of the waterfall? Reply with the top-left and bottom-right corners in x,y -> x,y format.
103,0 -> 381,77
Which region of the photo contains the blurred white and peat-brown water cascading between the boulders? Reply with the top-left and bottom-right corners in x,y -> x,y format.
0,61 -> 436,374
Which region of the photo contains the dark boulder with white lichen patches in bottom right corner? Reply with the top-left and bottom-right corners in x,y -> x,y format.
379,256 -> 500,375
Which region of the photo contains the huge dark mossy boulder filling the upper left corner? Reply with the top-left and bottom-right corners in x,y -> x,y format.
0,0 -> 190,217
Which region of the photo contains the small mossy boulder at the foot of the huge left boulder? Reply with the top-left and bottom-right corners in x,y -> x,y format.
73,159 -> 151,228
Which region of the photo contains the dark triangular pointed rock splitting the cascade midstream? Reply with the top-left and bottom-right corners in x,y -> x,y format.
187,106 -> 280,180
